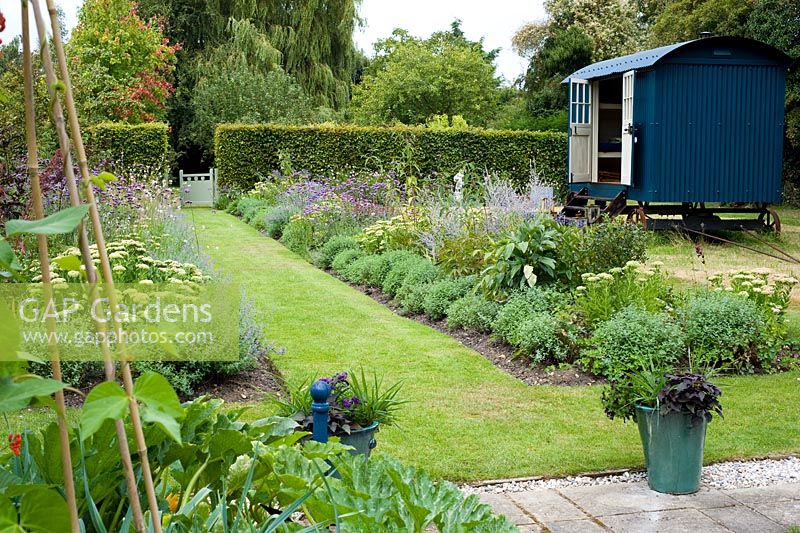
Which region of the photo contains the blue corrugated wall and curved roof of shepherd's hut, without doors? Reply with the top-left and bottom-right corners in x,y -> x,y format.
564,37 -> 789,203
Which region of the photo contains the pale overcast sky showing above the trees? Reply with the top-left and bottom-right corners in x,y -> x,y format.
0,0 -> 544,81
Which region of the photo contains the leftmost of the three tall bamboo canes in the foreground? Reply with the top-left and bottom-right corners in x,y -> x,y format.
22,1 -> 80,533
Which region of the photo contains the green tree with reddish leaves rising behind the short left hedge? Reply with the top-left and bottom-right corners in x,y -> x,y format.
66,0 -> 179,124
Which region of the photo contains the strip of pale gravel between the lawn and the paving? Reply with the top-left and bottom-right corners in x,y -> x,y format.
461,457 -> 800,494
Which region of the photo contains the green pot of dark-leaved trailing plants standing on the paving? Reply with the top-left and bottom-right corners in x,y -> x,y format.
603,371 -> 722,494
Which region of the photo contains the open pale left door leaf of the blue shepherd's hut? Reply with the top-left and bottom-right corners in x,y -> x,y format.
569,80 -> 592,183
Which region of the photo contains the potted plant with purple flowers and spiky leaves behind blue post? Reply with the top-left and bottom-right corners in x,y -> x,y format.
275,369 -> 406,457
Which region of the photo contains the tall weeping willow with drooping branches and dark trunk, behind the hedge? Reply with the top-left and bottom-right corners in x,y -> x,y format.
139,0 -> 360,167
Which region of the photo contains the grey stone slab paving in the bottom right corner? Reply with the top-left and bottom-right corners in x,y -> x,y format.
480,482 -> 800,533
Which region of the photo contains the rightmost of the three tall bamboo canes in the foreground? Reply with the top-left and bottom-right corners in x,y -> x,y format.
34,0 -> 161,533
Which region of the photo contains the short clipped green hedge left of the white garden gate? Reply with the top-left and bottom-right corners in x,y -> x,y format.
85,122 -> 169,174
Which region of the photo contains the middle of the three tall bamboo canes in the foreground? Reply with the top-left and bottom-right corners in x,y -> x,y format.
26,0 -> 145,532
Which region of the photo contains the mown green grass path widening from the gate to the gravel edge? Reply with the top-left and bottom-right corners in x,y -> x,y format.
193,209 -> 800,480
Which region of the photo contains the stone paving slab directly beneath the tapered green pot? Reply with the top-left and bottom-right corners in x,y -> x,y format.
559,481 -> 738,516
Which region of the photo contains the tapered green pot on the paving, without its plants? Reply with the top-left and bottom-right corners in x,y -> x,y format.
636,405 -> 706,494
